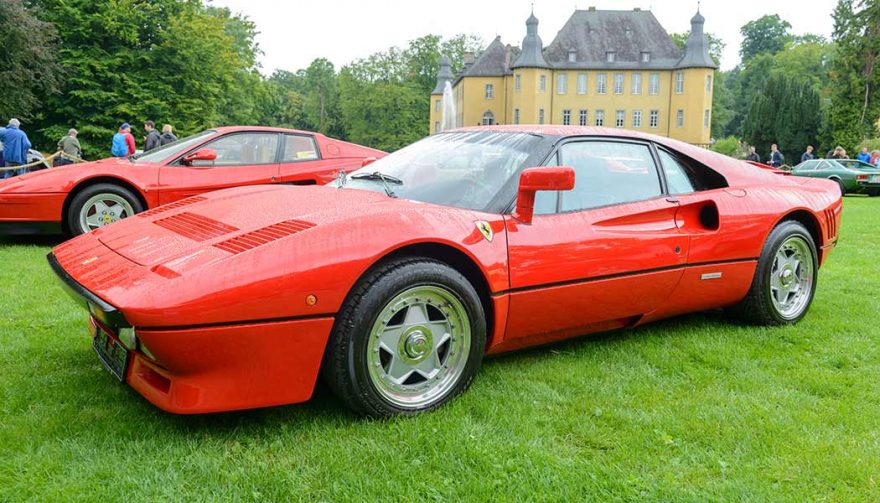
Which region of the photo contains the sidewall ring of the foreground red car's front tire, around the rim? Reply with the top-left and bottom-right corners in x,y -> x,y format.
339,260 -> 486,416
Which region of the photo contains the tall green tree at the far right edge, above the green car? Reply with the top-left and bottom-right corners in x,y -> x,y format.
828,0 -> 880,146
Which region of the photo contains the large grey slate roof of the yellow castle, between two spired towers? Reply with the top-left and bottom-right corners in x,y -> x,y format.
544,10 -> 682,69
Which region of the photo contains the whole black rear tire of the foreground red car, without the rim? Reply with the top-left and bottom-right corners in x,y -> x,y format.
728,220 -> 819,326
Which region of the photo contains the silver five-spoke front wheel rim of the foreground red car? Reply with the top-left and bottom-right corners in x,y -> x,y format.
367,285 -> 471,409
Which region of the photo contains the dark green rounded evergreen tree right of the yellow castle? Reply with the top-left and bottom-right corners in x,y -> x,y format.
743,75 -> 821,160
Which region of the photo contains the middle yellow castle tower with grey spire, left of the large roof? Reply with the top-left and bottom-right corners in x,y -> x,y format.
510,12 -> 553,124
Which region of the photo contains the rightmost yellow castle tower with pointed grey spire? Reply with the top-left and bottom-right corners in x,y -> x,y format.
667,8 -> 717,145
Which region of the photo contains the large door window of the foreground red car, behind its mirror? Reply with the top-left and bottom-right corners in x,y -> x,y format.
559,141 -> 662,212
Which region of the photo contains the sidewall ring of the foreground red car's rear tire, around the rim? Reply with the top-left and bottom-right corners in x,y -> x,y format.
757,221 -> 819,324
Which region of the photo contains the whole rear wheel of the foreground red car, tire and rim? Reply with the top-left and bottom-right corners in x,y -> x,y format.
731,221 -> 819,325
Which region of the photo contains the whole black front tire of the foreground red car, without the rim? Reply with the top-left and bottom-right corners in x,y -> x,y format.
322,257 -> 486,418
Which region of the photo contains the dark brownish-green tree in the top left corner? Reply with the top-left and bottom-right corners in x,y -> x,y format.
0,0 -> 61,120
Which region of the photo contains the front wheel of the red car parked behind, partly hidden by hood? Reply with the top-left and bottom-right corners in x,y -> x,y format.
67,183 -> 144,236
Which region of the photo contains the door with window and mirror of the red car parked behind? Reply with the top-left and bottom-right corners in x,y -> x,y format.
159,131 -> 280,204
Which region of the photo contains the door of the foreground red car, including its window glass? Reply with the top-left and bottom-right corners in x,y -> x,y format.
505,140 -> 687,343
